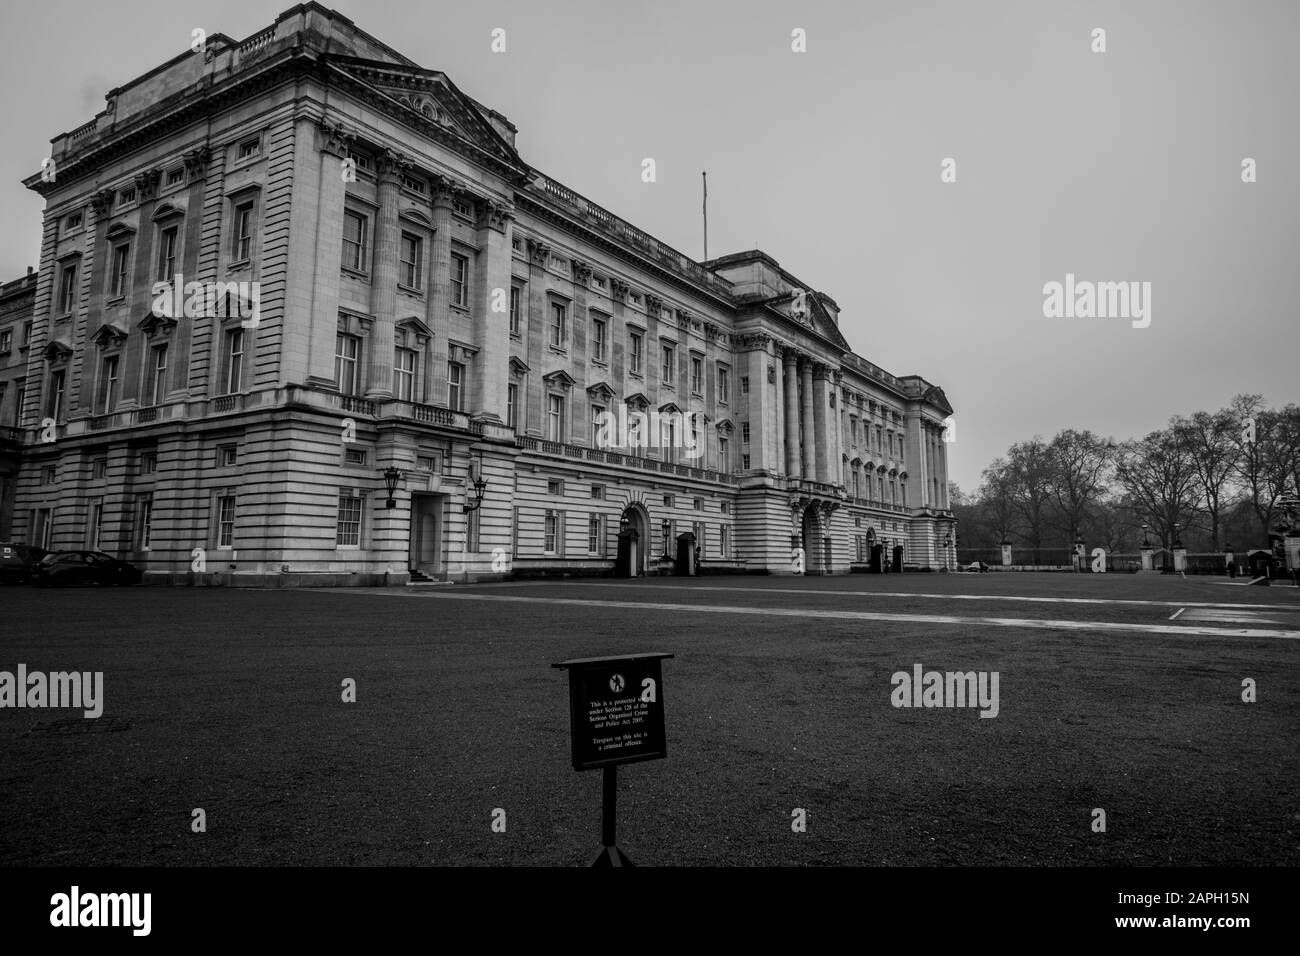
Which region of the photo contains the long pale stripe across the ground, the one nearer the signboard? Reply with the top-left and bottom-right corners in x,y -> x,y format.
338,588 -> 1300,640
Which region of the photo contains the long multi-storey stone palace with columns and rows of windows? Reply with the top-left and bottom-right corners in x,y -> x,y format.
10,3 -> 956,587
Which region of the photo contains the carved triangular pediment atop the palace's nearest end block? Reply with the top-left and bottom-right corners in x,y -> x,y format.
329,56 -> 525,169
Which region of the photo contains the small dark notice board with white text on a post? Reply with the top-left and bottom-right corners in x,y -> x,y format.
551,652 -> 672,866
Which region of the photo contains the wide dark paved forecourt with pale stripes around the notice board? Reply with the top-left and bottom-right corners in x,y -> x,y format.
0,574 -> 1300,865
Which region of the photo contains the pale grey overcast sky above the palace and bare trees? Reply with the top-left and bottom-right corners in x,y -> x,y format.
0,0 -> 1300,490
